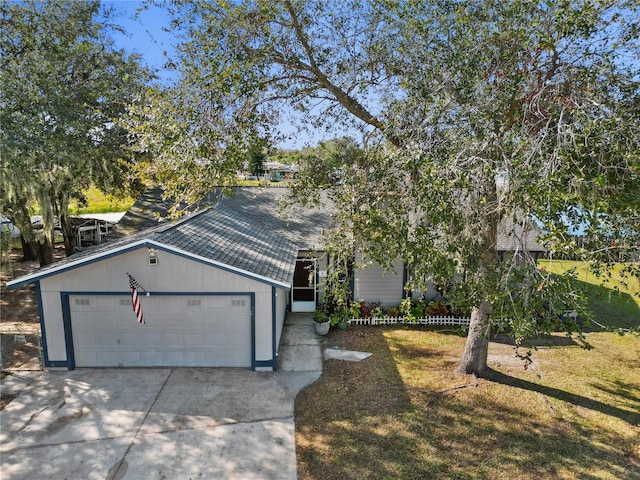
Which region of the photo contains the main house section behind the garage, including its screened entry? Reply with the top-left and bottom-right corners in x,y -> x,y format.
111,186 -> 406,311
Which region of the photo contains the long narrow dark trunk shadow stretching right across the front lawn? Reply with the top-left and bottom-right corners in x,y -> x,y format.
485,369 -> 640,426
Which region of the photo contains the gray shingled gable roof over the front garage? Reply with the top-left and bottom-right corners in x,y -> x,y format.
7,204 -> 298,288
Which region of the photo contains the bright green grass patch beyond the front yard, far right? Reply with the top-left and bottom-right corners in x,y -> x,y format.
539,260 -> 640,328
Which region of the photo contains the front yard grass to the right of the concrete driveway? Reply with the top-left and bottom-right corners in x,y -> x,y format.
296,326 -> 640,480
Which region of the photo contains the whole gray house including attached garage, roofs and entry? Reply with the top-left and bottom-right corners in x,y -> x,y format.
7,187 -> 544,370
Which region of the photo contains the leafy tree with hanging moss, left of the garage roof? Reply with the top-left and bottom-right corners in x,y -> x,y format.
0,1 -> 150,263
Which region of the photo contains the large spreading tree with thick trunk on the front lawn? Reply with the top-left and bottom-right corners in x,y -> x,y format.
133,0 -> 640,374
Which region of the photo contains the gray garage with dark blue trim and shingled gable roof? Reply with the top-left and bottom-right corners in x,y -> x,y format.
7,204 -> 299,370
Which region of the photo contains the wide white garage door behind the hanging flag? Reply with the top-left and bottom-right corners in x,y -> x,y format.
69,295 -> 251,367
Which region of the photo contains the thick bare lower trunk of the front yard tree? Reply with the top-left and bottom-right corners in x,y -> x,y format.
456,301 -> 491,377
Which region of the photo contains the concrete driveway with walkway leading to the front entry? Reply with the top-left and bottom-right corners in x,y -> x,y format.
0,314 -> 322,480
